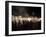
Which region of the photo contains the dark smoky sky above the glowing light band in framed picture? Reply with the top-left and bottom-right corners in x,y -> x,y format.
12,6 -> 41,17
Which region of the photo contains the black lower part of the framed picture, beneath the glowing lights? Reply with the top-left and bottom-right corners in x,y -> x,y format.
12,22 -> 41,31
